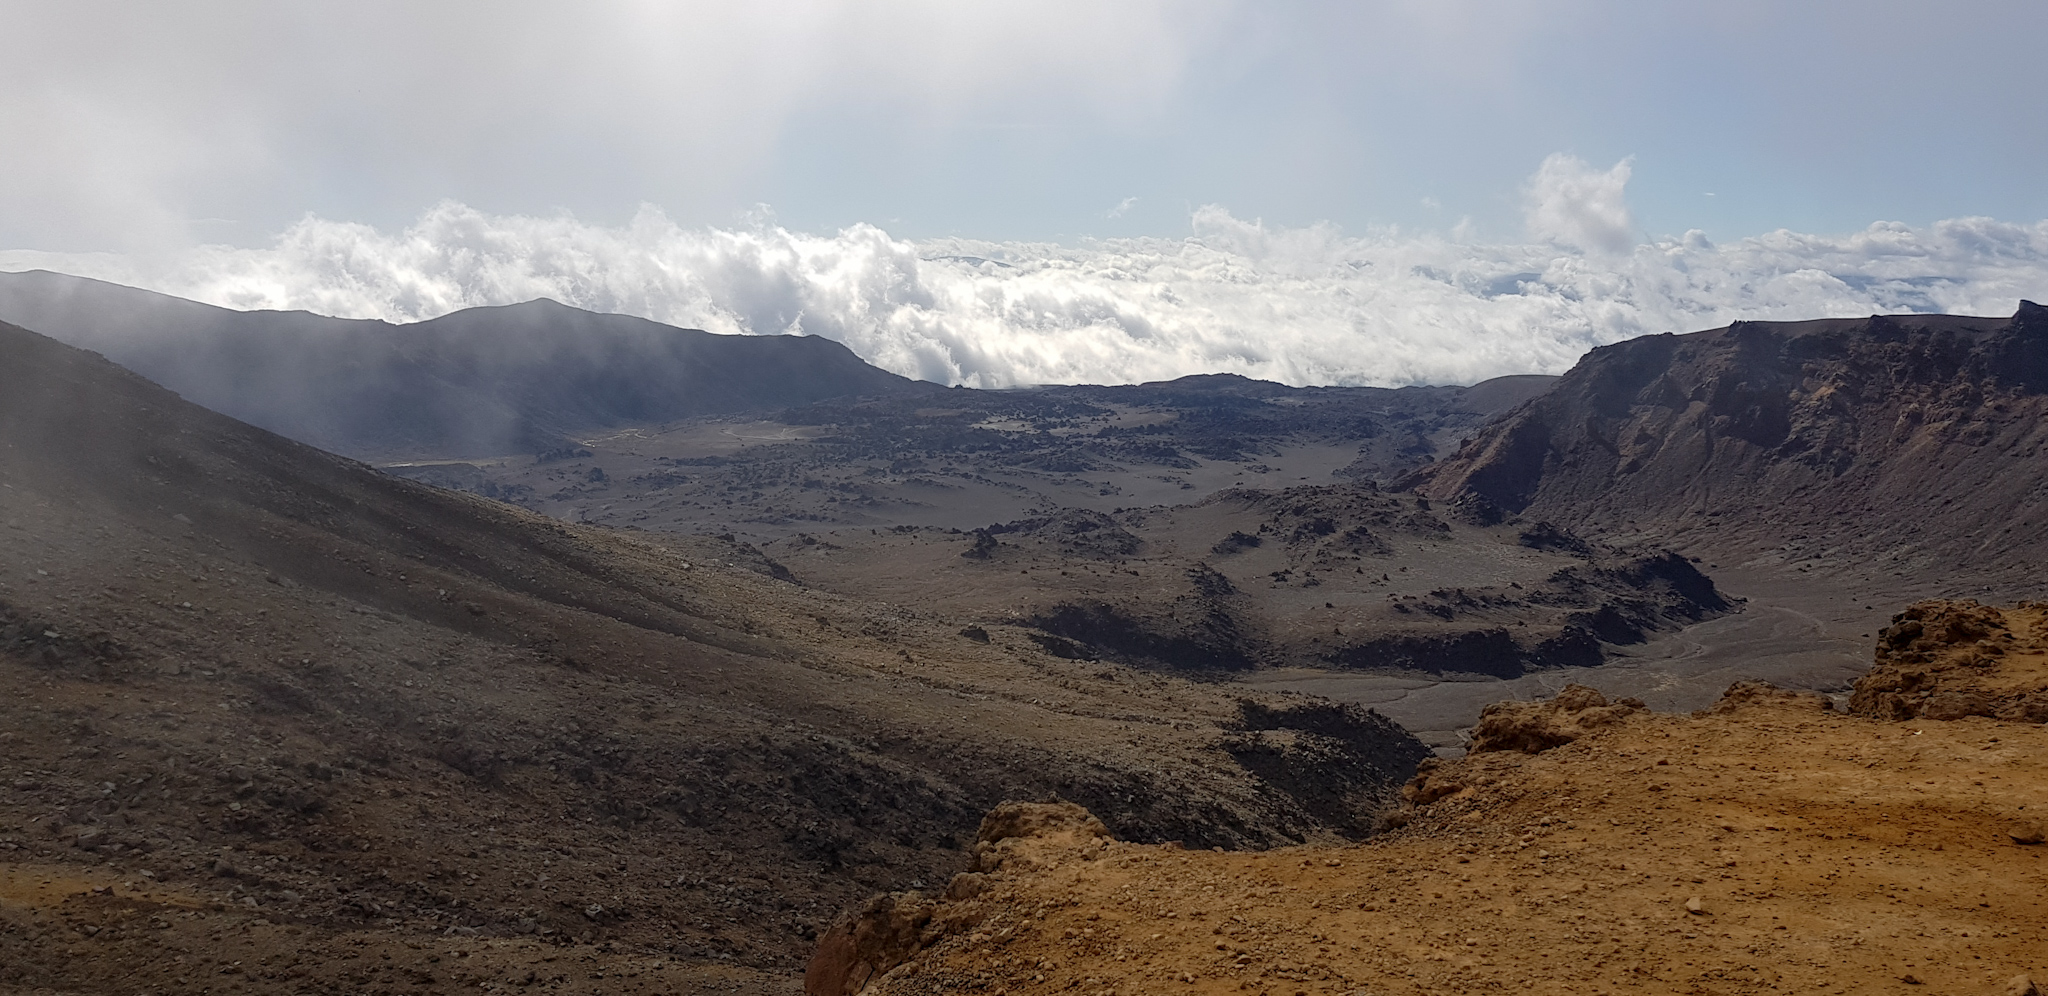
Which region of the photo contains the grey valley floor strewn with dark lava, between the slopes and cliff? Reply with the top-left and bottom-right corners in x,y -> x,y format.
372,377 -> 1810,746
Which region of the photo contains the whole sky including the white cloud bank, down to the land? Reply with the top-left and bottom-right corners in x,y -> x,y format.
0,0 -> 2048,387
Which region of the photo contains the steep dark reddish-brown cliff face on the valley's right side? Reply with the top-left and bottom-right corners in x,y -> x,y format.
1405,301 -> 2048,576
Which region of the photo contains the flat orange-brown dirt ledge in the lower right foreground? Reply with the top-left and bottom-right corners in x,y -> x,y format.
809,607 -> 2048,996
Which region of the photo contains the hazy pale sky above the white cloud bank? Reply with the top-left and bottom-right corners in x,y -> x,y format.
0,0 -> 2048,250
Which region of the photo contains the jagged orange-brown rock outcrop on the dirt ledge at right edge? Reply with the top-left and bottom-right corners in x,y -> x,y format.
1849,598 -> 2048,723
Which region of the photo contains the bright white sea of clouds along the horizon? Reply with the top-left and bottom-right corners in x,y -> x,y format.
0,156 -> 2048,387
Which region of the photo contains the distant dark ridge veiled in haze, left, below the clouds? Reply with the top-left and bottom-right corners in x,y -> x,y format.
0,271 -> 921,457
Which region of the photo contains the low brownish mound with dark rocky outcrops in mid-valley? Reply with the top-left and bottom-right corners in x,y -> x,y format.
764,484 -> 1735,678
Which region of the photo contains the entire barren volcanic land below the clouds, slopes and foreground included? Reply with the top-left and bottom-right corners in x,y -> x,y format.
0,275 -> 2048,996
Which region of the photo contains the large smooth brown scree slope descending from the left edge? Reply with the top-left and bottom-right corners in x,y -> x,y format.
0,326 -> 1423,992
